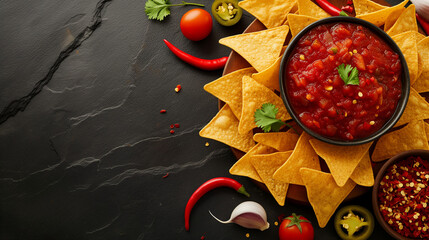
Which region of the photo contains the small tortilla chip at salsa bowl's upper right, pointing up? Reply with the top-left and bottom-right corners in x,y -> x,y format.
386,4 -> 419,36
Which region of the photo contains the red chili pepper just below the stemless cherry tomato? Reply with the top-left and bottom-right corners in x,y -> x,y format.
164,39 -> 228,70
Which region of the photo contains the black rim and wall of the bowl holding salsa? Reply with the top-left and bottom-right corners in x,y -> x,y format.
279,16 -> 410,146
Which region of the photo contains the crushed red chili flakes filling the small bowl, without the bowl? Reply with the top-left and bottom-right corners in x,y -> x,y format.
378,157 -> 429,239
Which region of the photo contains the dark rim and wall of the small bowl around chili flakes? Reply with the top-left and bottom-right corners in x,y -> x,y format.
372,150 -> 429,240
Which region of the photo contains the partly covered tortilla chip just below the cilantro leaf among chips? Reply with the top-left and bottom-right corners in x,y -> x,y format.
253,132 -> 299,152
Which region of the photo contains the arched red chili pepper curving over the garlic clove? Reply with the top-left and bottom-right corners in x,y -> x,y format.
185,177 -> 250,231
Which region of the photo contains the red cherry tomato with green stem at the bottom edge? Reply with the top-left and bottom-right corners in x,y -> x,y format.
279,213 -> 314,240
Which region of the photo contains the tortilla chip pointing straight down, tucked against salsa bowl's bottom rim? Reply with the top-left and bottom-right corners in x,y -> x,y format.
310,139 -> 372,187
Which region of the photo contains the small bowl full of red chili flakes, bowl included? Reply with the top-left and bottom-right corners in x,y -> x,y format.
372,150 -> 429,240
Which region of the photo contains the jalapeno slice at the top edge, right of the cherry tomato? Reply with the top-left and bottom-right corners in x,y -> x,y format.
212,0 -> 243,26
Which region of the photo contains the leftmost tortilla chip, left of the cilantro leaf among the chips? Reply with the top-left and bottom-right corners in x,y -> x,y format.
200,104 -> 255,152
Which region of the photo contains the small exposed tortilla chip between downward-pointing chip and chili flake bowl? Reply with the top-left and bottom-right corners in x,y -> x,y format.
350,152 -> 374,187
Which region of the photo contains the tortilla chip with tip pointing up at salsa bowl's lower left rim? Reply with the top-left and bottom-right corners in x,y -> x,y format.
273,132 -> 320,185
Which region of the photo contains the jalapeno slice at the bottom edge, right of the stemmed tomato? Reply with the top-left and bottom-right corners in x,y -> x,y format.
334,205 -> 374,240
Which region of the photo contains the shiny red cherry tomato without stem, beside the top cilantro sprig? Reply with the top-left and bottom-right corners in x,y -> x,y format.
180,8 -> 213,41
